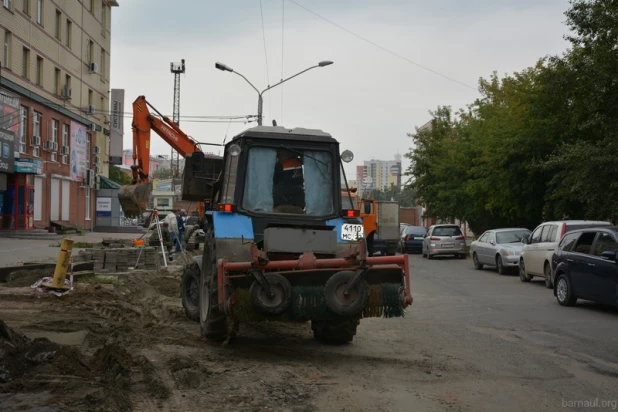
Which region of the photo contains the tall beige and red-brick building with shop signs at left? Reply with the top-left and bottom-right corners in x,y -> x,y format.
0,0 -> 118,230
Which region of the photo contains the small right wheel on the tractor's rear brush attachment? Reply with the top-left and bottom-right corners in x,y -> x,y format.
324,270 -> 369,316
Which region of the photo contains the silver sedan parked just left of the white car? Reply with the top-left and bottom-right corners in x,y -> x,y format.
470,228 -> 530,275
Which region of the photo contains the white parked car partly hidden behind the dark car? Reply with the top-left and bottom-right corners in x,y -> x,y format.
519,220 -> 611,289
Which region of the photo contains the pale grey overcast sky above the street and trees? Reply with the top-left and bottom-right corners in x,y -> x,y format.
111,0 -> 568,179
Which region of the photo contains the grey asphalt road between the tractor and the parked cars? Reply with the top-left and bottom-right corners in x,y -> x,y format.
366,251 -> 618,411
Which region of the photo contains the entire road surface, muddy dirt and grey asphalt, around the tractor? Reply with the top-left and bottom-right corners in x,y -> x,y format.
0,248 -> 618,412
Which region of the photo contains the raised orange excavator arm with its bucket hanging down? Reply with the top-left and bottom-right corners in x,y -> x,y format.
118,96 -> 204,219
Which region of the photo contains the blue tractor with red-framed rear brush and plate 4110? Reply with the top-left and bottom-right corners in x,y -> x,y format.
181,126 -> 412,343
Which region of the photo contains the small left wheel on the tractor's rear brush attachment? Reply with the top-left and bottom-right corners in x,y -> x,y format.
249,273 -> 292,315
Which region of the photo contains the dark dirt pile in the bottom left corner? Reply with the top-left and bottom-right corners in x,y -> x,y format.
0,320 -> 169,411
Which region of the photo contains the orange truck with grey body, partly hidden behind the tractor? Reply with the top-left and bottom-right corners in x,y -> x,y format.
341,189 -> 399,256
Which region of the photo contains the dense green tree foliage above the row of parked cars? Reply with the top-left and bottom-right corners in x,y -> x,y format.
406,0 -> 618,233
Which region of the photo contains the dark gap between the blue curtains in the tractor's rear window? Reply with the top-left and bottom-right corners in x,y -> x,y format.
273,149 -> 305,209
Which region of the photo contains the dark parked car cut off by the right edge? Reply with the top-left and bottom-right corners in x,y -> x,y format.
552,226 -> 618,306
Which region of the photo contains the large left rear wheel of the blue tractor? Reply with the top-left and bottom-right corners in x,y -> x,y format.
199,229 -> 236,342
